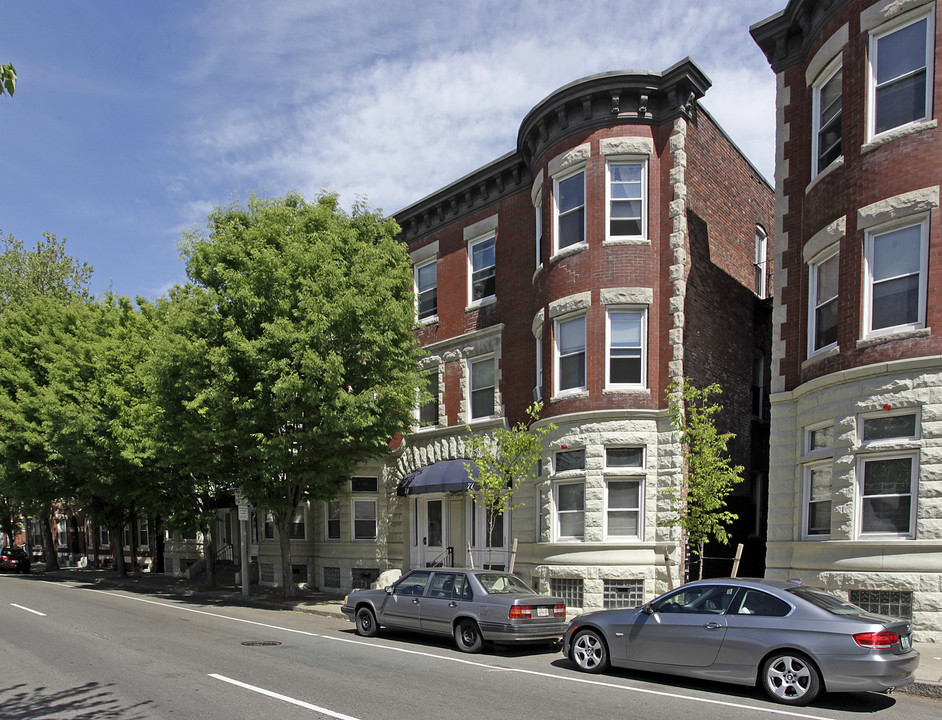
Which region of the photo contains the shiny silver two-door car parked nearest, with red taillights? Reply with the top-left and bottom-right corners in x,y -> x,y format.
563,579 -> 919,705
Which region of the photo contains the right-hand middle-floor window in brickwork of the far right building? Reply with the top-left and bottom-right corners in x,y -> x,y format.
864,217 -> 929,334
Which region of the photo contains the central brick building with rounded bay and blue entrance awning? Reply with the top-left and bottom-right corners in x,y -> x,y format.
272,59 -> 774,609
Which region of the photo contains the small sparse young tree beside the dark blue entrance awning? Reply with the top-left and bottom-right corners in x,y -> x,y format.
464,403 -> 556,566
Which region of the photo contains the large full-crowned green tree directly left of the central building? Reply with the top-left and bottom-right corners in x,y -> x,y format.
183,194 -> 422,596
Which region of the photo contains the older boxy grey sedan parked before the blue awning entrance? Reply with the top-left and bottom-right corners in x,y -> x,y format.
340,568 -> 566,653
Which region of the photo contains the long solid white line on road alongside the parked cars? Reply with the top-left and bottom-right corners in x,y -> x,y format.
81,588 -> 833,720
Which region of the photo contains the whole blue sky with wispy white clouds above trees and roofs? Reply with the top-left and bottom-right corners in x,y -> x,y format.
0,0 -> 786,297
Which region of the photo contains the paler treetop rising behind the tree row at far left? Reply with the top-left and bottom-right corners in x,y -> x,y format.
0,233 -> 92,313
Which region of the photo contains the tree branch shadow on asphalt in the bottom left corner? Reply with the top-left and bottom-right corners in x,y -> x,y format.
0,682 -> 150,720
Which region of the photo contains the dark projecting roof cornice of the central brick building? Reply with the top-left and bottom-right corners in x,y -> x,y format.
393,58 -> 712,248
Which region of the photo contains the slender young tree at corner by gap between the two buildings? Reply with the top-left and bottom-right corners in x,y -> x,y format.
665,378 -> 743,578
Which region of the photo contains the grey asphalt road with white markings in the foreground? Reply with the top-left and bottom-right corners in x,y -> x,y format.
0,575 -> 942,720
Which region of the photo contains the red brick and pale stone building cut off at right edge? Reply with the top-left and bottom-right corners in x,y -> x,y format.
751,0 -> 942,642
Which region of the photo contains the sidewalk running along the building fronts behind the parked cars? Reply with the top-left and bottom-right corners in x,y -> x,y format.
34,568 -> 942,698
